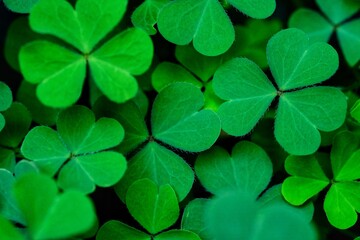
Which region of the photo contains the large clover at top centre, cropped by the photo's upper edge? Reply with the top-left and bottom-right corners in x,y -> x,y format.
158,0 -> 276,56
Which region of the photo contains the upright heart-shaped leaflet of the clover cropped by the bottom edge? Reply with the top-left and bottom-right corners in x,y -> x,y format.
126,179 -> 180,234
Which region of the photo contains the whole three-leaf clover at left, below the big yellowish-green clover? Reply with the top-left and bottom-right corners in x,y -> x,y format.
21,106 -> 126,193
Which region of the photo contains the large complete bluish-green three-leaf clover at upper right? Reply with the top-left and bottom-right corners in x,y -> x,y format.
213,29 -> 347,155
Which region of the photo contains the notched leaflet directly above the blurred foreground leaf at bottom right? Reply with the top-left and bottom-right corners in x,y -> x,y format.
195,141 -> 272,197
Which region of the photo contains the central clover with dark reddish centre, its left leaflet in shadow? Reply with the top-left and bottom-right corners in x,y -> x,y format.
94,83 -> 221,202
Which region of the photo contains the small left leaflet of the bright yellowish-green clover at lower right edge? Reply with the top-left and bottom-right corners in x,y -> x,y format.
281,155 -> 330,206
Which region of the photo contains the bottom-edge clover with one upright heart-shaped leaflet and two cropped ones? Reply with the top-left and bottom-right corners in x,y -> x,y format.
96,178 -> 200,240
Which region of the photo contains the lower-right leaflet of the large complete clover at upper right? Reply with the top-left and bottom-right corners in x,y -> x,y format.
275,87 -> 347,155
